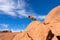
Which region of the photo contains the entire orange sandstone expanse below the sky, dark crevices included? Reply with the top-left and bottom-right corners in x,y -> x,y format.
0,6 -> 60,40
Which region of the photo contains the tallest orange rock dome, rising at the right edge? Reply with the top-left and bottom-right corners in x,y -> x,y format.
45,6 -> 60,40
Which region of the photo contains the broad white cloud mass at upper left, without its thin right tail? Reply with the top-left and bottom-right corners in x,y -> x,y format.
0,0 -> 28,16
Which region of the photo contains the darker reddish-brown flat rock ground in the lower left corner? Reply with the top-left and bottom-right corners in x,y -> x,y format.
0,31 -> 18,40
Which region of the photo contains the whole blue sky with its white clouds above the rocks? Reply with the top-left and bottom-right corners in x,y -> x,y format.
0,0 -> 60,31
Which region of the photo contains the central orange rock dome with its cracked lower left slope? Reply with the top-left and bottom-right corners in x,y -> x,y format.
13,21 -> 49,40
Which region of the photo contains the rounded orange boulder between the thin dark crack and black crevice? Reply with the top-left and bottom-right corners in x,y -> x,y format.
25,21 -> 49,40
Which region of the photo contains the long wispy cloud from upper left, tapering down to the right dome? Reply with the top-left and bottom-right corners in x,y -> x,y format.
0,0 -> 45,19
